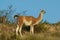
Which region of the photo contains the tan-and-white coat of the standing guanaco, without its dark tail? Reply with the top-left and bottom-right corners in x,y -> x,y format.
16,10 -> 45,36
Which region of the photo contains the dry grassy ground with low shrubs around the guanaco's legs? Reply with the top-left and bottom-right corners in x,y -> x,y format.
0,22 -> 60,40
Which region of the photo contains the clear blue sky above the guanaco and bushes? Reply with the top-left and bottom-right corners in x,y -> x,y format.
0,0 -> 60,23
